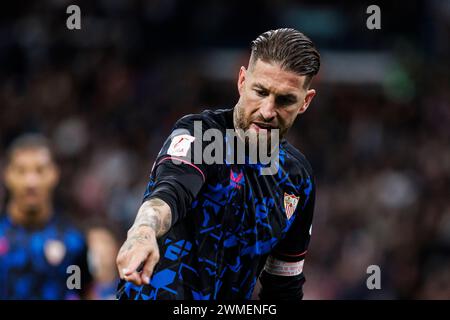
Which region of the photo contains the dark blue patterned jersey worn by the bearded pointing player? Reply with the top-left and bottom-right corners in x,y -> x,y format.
118,109 -> 315,300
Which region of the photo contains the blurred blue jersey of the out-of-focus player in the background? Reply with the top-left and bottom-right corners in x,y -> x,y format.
0,215 -> 90,300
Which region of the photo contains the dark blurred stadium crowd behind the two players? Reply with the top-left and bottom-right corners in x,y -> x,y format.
0,0 -> 450,299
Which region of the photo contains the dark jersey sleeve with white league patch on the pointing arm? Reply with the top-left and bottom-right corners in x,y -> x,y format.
144,115 -> 212,226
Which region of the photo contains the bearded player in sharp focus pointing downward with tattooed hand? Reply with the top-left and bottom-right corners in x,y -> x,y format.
117,29 -> 320,300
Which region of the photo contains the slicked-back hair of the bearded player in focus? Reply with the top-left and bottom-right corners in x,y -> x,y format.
250,28 -> 320,87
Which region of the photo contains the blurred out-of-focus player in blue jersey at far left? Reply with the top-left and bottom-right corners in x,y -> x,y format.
0,134 -> 90,300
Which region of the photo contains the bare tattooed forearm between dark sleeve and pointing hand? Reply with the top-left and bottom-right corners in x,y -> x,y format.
128,198 -> 172,238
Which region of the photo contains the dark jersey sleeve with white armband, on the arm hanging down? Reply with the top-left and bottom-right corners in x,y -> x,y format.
259,174 -> 315,300
